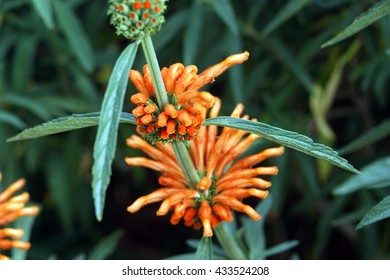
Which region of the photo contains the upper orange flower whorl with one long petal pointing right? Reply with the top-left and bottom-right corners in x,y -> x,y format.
129,52 -> 249,144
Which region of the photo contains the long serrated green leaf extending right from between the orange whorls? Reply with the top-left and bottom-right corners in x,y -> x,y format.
204,117 -> 359,173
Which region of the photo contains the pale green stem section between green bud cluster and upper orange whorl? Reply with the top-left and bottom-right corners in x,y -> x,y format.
141,36 -> 169,107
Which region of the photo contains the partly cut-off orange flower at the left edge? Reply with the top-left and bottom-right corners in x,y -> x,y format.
0,173 -> 39,260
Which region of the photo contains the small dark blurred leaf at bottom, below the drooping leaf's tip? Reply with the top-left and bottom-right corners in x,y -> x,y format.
88,230 -> 124,260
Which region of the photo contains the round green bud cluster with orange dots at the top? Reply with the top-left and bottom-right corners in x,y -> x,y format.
108,0 -> 166,39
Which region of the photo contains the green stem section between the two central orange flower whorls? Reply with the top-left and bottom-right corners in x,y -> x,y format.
172,142 -> 200,189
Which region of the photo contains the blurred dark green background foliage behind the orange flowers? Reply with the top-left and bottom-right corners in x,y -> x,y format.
0,0 -> 390,259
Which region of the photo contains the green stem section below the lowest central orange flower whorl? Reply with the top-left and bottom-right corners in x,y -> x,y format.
213,222 -> 248,260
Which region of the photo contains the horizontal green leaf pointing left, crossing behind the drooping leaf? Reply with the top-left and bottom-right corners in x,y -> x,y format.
6,112 -> 135,142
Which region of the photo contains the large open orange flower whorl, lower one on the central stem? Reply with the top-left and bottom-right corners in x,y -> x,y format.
126,99 -> 284,236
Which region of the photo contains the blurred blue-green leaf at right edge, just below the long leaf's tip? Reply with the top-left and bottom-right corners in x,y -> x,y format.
333,157 -> 390,195
